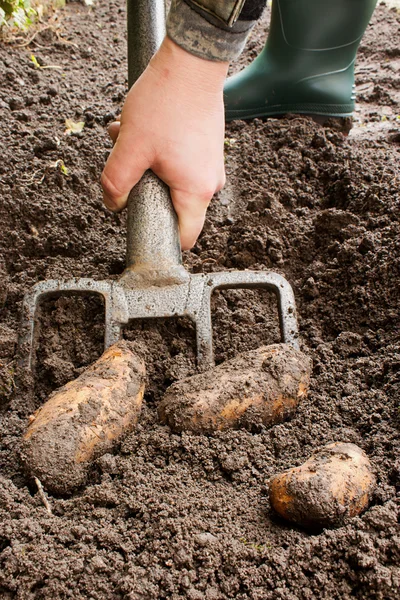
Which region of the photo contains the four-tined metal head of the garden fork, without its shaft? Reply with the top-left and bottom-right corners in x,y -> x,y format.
19,271 -> 298,371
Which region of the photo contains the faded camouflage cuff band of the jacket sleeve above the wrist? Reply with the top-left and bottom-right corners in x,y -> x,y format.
167,0 -> 255,62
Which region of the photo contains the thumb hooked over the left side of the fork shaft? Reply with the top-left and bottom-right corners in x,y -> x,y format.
101,127 -> 150,211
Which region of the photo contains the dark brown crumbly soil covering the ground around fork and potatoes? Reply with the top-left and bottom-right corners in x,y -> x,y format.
0,0 -> 400,600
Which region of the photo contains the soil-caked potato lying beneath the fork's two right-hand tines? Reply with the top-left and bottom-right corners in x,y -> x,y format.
158,344 -> 311,433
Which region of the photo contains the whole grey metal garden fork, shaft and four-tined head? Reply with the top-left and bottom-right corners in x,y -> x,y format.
20,0 -> 298,370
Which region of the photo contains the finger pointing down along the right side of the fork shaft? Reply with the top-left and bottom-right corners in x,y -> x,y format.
171,189 -> 212,250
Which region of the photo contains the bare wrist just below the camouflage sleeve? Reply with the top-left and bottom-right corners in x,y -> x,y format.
150,37 -> 229,95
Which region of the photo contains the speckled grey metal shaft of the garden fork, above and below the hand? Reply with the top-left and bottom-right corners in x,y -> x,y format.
125,0 -> 183,285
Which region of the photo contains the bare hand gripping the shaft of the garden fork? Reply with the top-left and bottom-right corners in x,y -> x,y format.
101,38 -> 228,250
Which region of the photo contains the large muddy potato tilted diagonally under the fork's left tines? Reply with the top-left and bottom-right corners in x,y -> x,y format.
21,342 -> 146,494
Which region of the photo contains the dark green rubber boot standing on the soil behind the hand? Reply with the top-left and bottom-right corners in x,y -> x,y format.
224,0 -> 377,121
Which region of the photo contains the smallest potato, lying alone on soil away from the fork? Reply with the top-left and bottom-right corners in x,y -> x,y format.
269,442 -> 375,529
